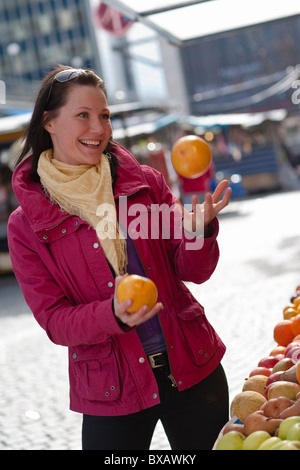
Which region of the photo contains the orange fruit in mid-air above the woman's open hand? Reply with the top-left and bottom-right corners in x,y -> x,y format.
171,135 -> 212,178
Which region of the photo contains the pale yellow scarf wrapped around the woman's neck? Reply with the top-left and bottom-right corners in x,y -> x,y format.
37,149 -> 127,275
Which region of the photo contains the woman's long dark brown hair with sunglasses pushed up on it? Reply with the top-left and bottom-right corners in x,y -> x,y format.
16,65 -> 118,182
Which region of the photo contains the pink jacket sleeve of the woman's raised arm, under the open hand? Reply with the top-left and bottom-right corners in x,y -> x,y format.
142,165 -> 219,284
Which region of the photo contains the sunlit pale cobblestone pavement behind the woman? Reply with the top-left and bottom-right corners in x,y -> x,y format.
0,191 -> 300,450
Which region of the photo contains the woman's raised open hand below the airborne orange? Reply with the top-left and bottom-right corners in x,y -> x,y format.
176,180 -> 232,234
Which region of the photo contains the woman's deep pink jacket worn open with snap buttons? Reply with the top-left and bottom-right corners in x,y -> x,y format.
8,143 -> 225,415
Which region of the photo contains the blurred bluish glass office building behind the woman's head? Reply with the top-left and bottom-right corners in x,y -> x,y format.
0,0 -> 101,105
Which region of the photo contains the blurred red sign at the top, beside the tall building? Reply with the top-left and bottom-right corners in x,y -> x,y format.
95,2 -> 133,37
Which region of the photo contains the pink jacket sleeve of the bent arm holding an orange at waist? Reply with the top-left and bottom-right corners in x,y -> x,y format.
8,209 -> 124,346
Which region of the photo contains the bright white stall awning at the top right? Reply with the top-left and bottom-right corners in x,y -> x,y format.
105,0 -> 300,45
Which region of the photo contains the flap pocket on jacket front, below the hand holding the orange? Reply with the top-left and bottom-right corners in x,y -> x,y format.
71,343 -> 120,402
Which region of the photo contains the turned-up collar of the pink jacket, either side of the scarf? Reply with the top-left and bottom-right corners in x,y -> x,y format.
12,145 -> 149,232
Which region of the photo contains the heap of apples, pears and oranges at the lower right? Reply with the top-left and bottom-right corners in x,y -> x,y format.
213,286 -> 300,450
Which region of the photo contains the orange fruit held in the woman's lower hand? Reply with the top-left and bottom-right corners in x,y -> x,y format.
117,274 -> 158,313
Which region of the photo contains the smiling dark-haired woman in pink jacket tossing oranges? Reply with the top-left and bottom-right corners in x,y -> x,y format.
8,66 -> 230,450
